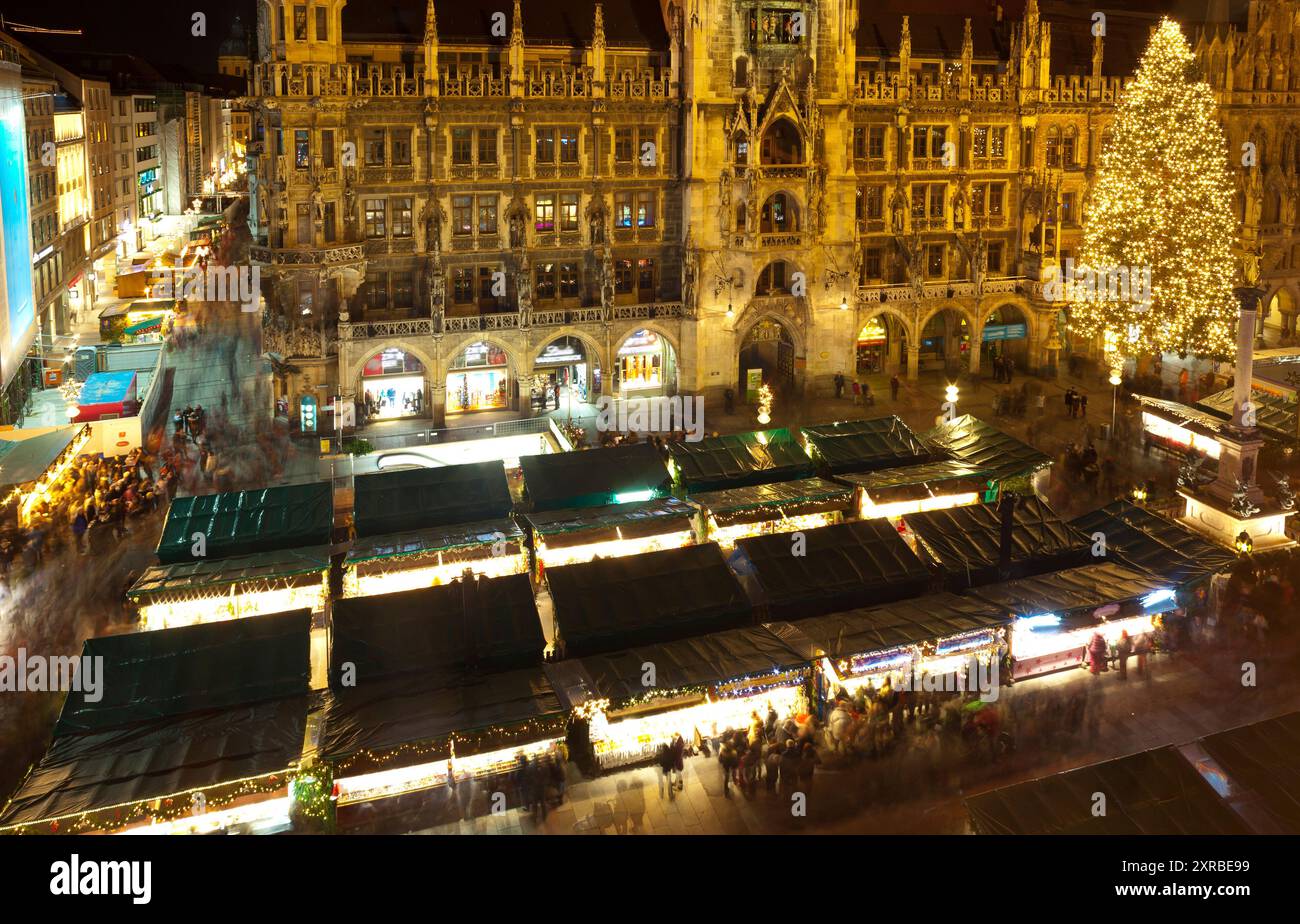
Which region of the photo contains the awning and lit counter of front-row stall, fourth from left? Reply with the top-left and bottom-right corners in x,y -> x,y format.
798,593 -> 1011,694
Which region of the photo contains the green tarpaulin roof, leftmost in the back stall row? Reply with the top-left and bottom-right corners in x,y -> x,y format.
157,481 -> 334,564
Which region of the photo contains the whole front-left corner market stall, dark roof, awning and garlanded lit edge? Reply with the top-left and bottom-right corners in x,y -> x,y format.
0,610 -> 311,834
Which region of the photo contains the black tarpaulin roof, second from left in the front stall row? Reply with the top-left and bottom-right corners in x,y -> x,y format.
330,574 -> 546,687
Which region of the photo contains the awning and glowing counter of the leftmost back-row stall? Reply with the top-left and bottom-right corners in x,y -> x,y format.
126,546 -> 329,630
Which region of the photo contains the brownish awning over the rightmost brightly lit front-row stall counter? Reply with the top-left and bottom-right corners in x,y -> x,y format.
970,561 -> 1169,616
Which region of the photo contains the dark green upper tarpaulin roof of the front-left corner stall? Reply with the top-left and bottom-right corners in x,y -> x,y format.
55,610 -> 312,737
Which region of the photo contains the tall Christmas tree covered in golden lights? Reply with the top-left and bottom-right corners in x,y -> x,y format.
1066,19 -> 1236,359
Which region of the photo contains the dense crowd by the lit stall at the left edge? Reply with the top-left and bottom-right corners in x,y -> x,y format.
0,448 -> 177,578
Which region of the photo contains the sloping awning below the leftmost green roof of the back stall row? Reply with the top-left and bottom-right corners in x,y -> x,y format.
126,546 -> 329,603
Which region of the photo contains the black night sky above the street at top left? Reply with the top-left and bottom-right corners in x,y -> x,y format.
0,0 -> 254,75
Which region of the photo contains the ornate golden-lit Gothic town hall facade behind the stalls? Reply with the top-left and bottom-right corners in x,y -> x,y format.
248,0 -> 1300,425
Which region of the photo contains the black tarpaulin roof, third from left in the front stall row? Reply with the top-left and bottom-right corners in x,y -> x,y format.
546,542 -> 751,658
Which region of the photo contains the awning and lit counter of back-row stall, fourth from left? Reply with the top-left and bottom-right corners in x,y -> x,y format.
690,478 -> 853,550
